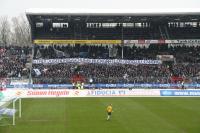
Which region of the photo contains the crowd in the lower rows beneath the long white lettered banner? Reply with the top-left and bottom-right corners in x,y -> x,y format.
32,64 -> 200,83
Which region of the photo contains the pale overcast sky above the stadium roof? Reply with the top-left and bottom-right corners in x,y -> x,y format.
0,0 -> 200,17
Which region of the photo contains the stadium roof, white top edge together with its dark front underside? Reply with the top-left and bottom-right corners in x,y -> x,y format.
26,9 -> 200,25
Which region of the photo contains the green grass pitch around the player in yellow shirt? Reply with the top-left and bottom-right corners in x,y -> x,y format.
0,98 -> 200,133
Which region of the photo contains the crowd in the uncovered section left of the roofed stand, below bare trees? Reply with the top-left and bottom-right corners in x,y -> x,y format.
0,46 -> 31,78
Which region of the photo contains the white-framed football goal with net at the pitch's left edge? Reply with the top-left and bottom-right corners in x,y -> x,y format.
0,98 -> 22,126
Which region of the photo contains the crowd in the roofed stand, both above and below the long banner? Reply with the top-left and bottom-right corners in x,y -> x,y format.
32,44 -> 200,83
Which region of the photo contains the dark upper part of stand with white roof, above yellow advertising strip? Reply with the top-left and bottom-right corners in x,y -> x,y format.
26,9 -> 200,40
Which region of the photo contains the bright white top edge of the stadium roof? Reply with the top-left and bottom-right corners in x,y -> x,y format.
26,8 -> 200,16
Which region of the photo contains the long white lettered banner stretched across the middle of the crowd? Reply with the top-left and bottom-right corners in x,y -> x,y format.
33,58 -> 162,65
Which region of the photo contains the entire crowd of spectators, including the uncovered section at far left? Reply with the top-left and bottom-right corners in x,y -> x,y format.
0,45 -> 200,83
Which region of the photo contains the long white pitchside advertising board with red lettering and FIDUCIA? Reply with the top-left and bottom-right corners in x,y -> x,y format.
3,89 -> 160,98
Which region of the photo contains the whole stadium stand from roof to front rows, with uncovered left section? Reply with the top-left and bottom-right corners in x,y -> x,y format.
0,11 -> 200,88
